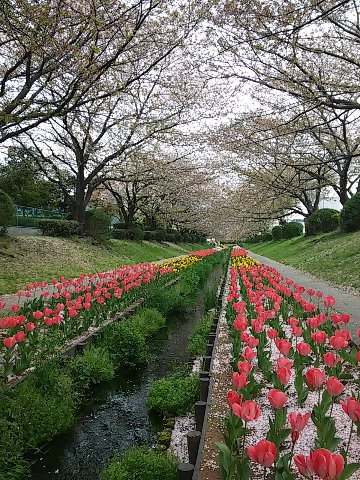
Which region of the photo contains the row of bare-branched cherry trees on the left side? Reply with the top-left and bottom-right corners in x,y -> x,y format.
0,0 -> 222,236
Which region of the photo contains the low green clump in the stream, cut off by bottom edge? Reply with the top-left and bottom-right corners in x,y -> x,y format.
100,447 -> 179,480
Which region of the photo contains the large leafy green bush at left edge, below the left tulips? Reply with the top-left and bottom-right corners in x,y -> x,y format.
1,362 -> 77,450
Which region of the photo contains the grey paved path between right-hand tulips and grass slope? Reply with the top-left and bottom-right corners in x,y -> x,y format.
249,252 -> 360,344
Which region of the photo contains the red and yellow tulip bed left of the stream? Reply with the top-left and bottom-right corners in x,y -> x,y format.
0,249 -> 217,381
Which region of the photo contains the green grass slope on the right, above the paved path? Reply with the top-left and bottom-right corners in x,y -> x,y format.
246,232 -> 360,290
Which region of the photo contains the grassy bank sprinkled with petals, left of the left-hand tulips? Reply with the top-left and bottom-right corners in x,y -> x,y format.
0,236 -> 208,294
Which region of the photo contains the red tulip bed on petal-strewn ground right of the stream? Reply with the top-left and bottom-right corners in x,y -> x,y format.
218,249 -> 360,480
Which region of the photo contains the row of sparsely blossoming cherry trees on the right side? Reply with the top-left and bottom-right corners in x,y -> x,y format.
210,0 -> 360,237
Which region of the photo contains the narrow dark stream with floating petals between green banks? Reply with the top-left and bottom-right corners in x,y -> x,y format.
31,266 -> 222,480
